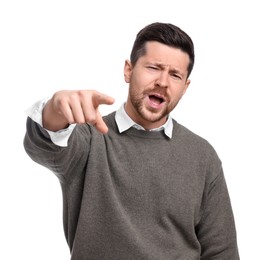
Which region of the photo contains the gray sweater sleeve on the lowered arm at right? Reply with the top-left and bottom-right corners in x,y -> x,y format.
196,149 -> 239,260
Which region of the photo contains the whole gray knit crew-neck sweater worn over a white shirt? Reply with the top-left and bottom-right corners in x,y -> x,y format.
24,113 -> 239,260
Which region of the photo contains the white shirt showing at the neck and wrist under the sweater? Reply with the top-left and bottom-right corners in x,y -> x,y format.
26,98 -> 173,147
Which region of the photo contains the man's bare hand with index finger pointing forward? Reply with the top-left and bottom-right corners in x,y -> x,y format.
43,90 -> 114,133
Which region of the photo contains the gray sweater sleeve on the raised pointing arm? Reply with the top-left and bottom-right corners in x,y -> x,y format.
23,117 -> 91,182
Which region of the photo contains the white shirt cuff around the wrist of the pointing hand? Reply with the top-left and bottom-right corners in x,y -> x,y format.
26,98 -> 76,147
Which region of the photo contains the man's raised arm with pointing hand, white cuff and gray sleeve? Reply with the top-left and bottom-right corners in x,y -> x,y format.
24,90 -> 114,180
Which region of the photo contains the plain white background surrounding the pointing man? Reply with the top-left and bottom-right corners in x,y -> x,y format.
0,0 -> 267,260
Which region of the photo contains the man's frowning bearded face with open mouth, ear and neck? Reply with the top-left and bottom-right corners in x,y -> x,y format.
124,41 -> 190,129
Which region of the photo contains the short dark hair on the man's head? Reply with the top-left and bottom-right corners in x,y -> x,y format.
130,22 -> 195,77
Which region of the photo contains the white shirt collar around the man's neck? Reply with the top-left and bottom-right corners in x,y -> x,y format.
115,104 -> 173,138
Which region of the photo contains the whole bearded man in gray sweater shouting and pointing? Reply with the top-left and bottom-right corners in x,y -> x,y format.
24,23 -> 239,260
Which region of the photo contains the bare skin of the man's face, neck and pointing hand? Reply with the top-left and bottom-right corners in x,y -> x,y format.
43,42 -> 190,134
